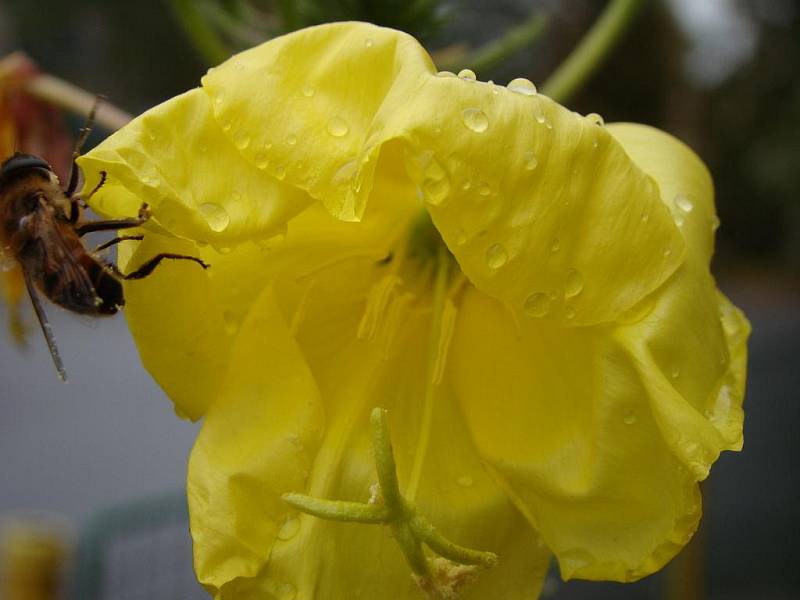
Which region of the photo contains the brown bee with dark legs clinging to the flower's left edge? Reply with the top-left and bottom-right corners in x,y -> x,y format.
0,103 -> 208,381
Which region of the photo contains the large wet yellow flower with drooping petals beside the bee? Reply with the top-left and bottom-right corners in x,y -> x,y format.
81,23 -> 749,599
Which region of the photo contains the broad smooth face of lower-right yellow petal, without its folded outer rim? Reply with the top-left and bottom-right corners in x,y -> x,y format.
448,291 -> 700,581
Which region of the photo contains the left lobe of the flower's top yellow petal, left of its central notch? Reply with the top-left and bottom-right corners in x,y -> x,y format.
203,23 -> 433,221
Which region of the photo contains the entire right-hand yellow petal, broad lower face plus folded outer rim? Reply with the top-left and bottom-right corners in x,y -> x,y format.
452,125 -> 749,581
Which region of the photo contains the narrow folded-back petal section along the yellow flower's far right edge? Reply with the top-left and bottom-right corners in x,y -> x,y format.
613,124 -> 750,479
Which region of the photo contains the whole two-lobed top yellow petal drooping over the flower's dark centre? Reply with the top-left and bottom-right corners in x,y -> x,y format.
204,23 -> 683,324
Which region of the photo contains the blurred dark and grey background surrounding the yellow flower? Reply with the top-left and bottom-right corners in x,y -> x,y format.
0,0 -> 800,600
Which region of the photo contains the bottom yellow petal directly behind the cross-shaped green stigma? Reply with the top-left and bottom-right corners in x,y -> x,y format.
190,243 -> 548,600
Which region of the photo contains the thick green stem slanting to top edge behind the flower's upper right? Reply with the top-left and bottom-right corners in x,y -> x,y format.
541,0 -> 647,103
